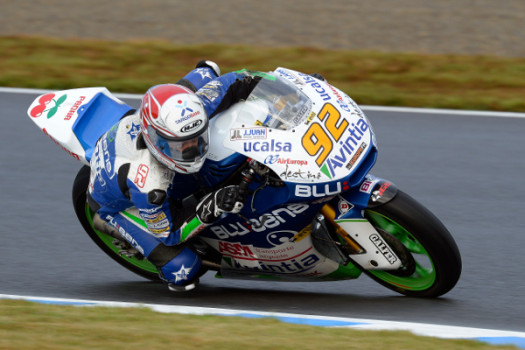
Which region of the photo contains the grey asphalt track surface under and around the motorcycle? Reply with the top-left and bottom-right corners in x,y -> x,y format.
0,92 -> 525,331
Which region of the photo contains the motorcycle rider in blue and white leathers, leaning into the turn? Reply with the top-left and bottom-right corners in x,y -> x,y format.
87,61 -> 260,291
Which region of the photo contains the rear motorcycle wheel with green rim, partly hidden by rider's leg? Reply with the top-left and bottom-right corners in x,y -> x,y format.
73,166 -> 161,281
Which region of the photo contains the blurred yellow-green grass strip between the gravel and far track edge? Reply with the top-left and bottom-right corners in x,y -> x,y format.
0,37 -> 525,112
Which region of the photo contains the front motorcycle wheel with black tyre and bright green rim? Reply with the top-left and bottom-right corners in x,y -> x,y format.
365,191 -> 462,297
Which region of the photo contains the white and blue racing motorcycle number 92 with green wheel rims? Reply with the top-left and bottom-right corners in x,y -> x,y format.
28,67 -> 462,297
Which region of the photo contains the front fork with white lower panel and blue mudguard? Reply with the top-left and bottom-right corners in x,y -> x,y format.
321,175 -> 402,270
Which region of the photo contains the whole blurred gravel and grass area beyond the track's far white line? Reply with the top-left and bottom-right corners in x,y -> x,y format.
0,0 -> 525,112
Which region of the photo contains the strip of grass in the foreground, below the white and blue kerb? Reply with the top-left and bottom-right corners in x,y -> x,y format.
0,300 -> 516,350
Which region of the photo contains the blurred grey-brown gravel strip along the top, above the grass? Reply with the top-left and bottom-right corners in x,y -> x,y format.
0,0 -> 525,57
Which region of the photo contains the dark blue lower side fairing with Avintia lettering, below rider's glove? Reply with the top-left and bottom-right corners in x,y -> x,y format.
196,198 -> 339,280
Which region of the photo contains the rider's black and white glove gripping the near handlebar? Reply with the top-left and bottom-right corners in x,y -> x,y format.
196,186 -> 243,224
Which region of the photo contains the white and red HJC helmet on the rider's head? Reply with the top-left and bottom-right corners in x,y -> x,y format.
139,84 -> 209,174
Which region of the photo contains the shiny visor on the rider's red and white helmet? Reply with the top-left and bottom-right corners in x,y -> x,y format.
147,126 -> 209,162
